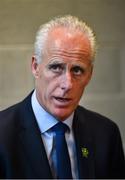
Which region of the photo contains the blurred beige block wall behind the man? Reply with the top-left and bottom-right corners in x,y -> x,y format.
0,0 -> 125,149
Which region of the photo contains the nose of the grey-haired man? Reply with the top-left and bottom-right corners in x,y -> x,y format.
61,72 -> 73,91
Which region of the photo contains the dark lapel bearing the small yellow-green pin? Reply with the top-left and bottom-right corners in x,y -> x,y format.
73,108 -> 95,179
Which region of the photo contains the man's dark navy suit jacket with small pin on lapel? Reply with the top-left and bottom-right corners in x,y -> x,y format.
0,94 -> 125,179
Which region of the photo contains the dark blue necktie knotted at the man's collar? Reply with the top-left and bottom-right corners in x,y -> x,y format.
52,122 -> 72,179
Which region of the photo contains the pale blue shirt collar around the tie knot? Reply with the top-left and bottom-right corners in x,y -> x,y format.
31,90 -> 74,133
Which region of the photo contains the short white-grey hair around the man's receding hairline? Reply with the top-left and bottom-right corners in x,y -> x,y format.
34,15 -> 96,64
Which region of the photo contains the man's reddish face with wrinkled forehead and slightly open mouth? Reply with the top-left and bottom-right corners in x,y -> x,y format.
32,28 -> 92,120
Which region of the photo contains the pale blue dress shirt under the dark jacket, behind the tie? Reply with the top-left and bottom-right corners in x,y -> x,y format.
31,91 -> 78,179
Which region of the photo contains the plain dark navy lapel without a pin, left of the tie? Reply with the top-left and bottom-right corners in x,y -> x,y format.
20,93 -> 52,179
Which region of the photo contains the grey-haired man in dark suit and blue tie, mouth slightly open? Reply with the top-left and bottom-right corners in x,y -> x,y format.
0,16 -> 125,179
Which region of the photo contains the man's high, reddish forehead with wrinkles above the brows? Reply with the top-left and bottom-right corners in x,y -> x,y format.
45,27 -> 91,63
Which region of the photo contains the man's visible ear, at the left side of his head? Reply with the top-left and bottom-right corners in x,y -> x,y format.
31,56 -> 39,78
